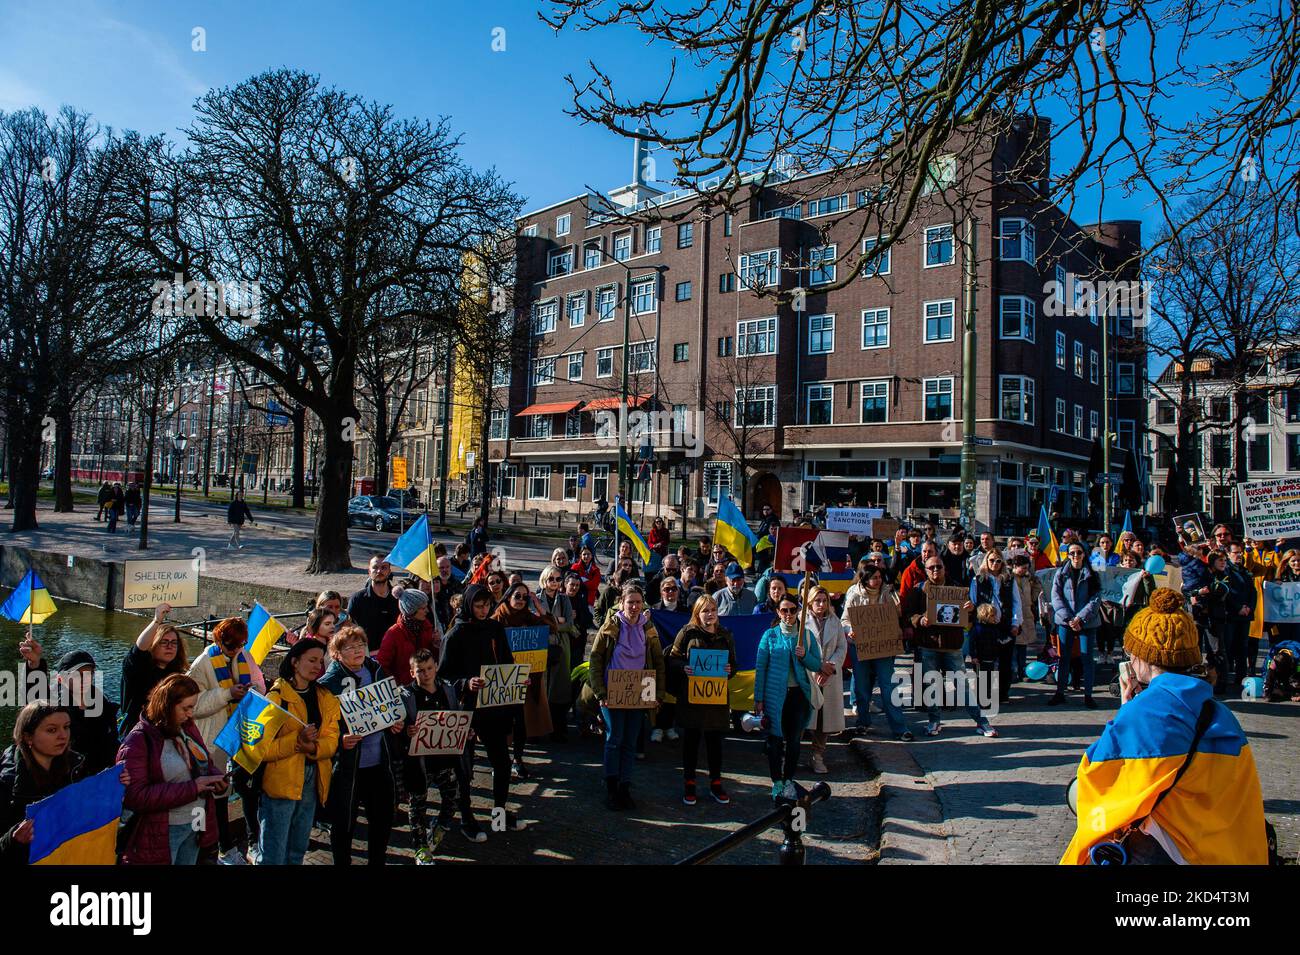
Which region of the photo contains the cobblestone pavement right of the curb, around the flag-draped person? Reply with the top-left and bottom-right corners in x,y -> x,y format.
868,670 -> 1300,864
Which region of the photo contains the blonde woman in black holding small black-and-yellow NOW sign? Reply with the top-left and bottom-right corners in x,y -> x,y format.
666,594 -> 736,806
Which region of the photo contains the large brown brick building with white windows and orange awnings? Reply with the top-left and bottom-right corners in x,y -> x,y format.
489,120 -> 1147,533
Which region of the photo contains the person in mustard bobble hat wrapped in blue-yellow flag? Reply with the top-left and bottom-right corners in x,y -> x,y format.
1061,587 -> 1268,865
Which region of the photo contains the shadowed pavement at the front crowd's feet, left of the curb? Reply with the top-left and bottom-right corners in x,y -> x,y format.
306,733 -> 878,865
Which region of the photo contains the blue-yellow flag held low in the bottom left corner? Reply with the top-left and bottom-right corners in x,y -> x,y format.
27,765 -> 126,865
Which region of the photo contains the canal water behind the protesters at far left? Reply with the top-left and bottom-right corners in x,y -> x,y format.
0,590 -> 203,747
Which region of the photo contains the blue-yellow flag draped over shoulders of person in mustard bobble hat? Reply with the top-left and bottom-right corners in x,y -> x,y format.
1061,673 -> 1269,865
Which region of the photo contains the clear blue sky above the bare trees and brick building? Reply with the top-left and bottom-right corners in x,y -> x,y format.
0,0 -> 1268,231
